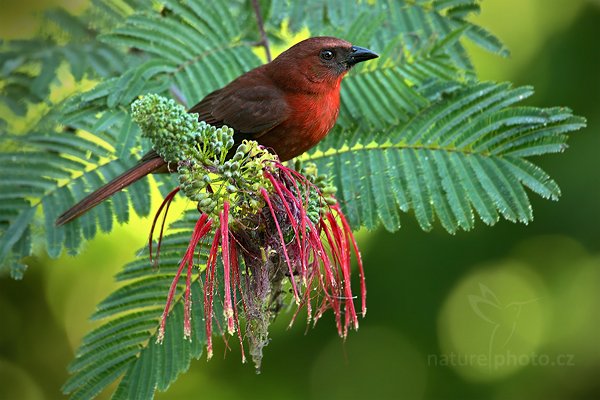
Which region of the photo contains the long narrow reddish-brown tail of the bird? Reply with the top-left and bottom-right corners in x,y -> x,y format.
56,157 -> 165,226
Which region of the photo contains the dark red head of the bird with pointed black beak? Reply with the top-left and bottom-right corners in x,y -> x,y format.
271,36 -> 379,90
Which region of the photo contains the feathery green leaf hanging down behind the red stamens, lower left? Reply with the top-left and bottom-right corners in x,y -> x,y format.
63,210 -> 213,399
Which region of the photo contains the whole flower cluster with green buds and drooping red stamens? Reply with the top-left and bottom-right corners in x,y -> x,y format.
132,95 -> 366,368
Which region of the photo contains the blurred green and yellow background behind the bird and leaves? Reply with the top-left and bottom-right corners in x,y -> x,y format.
0,0 -> 600,399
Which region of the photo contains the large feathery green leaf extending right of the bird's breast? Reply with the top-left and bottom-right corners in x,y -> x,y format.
306,81 -> 585,233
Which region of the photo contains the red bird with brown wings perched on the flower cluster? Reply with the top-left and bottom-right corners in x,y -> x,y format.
56,37 -> 378,225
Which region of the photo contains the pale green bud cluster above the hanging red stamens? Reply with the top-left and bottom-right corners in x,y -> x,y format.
132,94 -> 277,218
